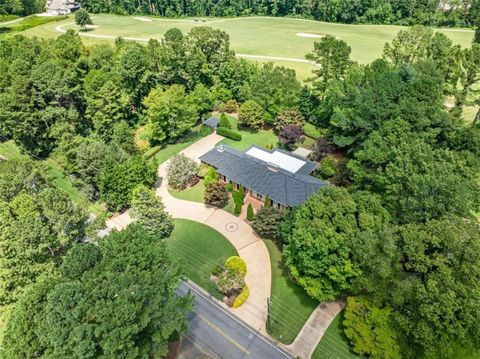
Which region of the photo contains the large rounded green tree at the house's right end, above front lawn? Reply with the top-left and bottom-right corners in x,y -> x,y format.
282,187 -> 389,302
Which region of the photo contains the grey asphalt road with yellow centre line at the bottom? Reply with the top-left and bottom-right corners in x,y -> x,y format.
178,282 -> 293,359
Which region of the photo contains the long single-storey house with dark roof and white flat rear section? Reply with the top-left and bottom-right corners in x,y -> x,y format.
200,145 -> 329,208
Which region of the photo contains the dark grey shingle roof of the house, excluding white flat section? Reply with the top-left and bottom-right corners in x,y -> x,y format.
200,146 -> 329,207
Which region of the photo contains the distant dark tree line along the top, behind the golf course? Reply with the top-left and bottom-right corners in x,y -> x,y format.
0,0 -> 480,26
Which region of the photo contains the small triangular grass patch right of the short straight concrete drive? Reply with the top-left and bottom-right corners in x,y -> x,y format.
312,311 -> 362,359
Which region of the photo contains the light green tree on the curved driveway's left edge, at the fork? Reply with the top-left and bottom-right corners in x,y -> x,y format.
130,185 -> 174,239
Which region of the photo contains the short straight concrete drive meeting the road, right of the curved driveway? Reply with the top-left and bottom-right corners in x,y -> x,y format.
286,300 -> 345,359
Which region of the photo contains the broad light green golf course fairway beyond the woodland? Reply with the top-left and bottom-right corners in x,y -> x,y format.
17,14 -> 473,79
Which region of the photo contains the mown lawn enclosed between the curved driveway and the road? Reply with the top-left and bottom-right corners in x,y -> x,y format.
166,219 -> 238,296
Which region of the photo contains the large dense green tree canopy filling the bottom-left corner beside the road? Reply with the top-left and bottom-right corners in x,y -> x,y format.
5,225 -> 191,358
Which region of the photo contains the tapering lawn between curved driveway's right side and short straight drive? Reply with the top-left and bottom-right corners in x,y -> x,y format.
264,240 -> 318,344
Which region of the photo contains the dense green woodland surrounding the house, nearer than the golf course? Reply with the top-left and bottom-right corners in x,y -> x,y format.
0,20 -> 480,358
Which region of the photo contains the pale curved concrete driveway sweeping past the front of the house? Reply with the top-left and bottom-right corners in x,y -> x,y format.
107,133 -> 272,334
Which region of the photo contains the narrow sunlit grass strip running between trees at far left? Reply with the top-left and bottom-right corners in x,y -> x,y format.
0,141 -> 105,215
